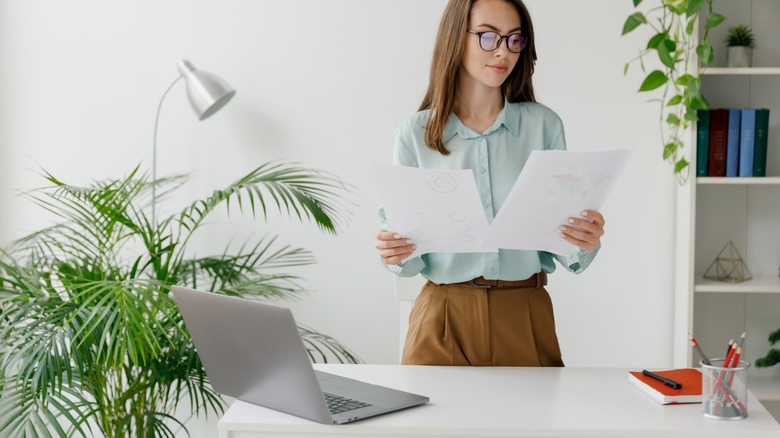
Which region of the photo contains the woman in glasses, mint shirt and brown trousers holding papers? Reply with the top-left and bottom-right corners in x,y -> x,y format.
376,0 -> 604,366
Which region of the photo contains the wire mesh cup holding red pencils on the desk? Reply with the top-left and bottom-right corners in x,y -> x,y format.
700,359 -> 750,420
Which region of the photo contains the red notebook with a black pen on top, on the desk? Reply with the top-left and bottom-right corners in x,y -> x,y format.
628,368 -> 702,405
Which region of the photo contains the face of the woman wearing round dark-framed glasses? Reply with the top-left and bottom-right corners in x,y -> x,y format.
461,0 -> 521,92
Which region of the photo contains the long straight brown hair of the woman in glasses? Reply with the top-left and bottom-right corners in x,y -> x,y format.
420,0 -> 536,155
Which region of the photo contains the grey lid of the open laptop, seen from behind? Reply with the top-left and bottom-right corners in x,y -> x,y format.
171,286 -> 331,422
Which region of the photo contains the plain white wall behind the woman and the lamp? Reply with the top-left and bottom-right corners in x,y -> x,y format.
0,0 -> 675,434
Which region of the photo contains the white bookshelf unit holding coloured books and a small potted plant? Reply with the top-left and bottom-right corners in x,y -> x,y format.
674,0 -> 780,419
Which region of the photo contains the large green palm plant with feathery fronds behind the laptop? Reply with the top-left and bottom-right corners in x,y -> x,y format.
0,163 -> 357,438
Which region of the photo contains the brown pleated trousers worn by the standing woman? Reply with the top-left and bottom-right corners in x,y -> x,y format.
401,281 -> 563,367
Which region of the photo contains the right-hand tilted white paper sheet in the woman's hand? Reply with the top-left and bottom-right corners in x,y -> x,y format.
485,149 -> 632,255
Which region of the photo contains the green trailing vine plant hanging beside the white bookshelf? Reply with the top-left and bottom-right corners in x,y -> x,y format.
622,0 -> 725,183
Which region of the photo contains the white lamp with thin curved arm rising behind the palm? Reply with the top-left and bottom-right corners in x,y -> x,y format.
152,59 -> 236,227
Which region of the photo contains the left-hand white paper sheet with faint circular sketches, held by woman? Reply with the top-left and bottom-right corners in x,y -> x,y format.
374,164 -> 498,257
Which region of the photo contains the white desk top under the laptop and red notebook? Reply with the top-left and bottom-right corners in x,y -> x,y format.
219,365 -> 780,438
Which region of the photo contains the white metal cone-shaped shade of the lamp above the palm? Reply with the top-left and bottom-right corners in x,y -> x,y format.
178,59 -> 236,120
